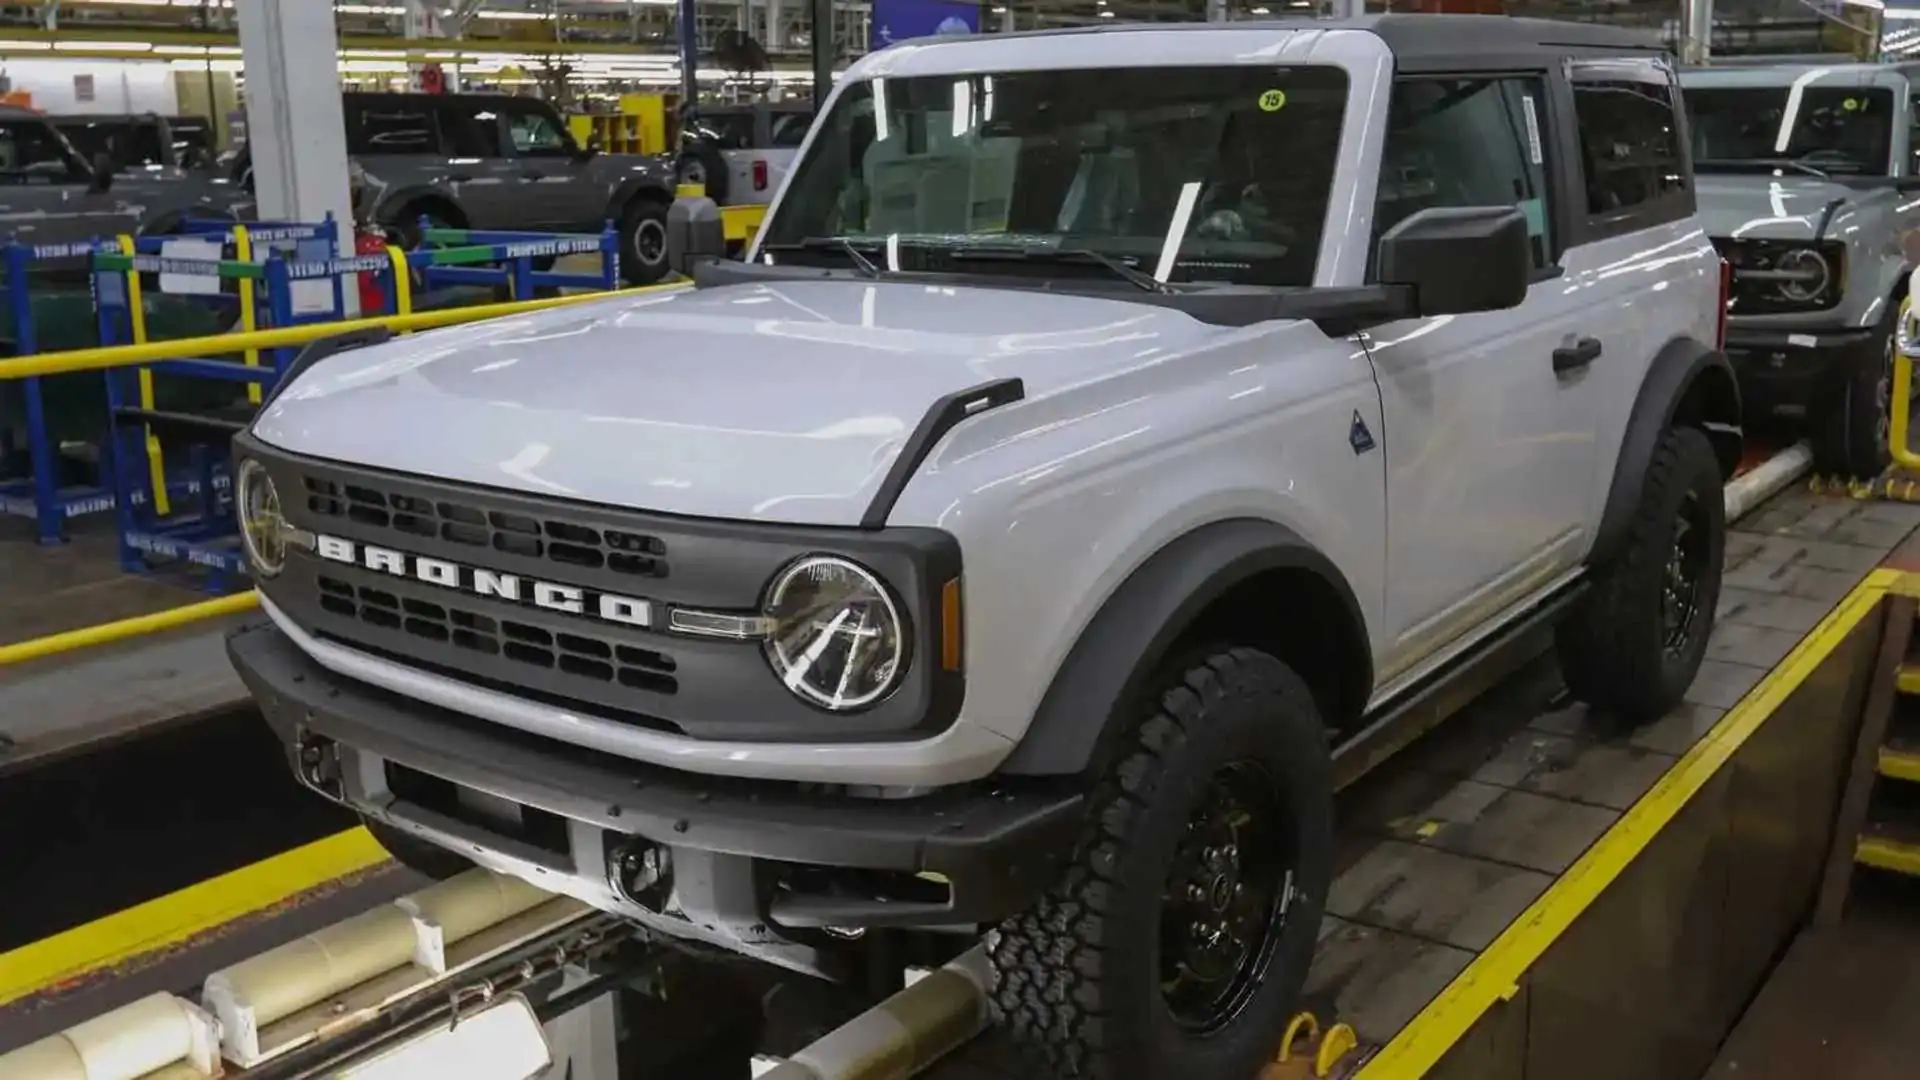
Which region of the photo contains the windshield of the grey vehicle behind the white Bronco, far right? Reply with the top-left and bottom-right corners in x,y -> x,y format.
1686,85 -> 1893,177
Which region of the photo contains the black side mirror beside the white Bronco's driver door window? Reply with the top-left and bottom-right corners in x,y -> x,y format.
1377,206 -> 1534,315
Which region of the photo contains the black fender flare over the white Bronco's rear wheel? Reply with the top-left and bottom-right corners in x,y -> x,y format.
1590,338 -> 1743,563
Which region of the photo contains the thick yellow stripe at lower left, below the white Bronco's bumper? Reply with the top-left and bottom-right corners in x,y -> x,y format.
0,828 -> 388,1005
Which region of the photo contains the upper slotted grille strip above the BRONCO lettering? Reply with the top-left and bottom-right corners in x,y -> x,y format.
301,475 -> 668,578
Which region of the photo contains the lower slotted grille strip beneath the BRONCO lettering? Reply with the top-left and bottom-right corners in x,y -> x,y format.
317,575 -> 680,696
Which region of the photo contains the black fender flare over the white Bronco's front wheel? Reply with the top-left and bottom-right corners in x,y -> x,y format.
1000,517 -> 1373,776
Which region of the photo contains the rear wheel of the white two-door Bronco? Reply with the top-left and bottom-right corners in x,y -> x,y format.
1555,427 -> 1726,723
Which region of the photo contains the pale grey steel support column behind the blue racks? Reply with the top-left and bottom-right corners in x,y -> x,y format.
238,0 -> 359,313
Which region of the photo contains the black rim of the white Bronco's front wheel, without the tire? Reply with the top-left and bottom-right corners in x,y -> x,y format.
1160,761 -> 1296,1034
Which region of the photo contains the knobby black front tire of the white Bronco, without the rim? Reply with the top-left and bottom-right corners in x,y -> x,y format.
987,648 -> 1332,1080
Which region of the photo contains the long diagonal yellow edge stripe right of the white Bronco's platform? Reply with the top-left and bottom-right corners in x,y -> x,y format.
1354,569 -> 1903,1080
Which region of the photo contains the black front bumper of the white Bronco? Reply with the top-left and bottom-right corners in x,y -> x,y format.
227,623 -> 1085,926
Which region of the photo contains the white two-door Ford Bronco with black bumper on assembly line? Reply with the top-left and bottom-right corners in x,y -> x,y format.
230,15 -> 1740,1080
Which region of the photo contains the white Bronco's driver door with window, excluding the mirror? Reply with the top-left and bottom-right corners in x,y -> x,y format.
1367,73 -> 1597,678
